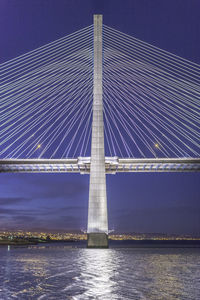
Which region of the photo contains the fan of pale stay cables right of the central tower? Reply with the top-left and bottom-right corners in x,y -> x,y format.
103,25 -> 200,158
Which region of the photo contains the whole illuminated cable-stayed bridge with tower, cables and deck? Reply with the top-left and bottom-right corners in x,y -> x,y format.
0,15 -> 200,247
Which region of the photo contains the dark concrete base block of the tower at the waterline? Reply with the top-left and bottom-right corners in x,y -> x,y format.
87,232 -> 108,248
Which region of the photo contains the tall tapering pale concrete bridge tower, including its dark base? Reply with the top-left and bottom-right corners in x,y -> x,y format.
87,15 -> 108,248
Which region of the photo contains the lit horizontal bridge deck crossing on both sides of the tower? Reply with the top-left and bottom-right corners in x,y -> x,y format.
0,157 -> 200,174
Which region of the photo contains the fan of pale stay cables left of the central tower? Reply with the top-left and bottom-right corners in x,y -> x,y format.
0,26 -> 93,158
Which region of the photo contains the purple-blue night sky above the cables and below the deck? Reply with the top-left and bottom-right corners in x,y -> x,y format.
0,0 -> 200,234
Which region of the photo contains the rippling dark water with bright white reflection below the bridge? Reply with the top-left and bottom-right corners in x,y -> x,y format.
0,243 -> 200,300
